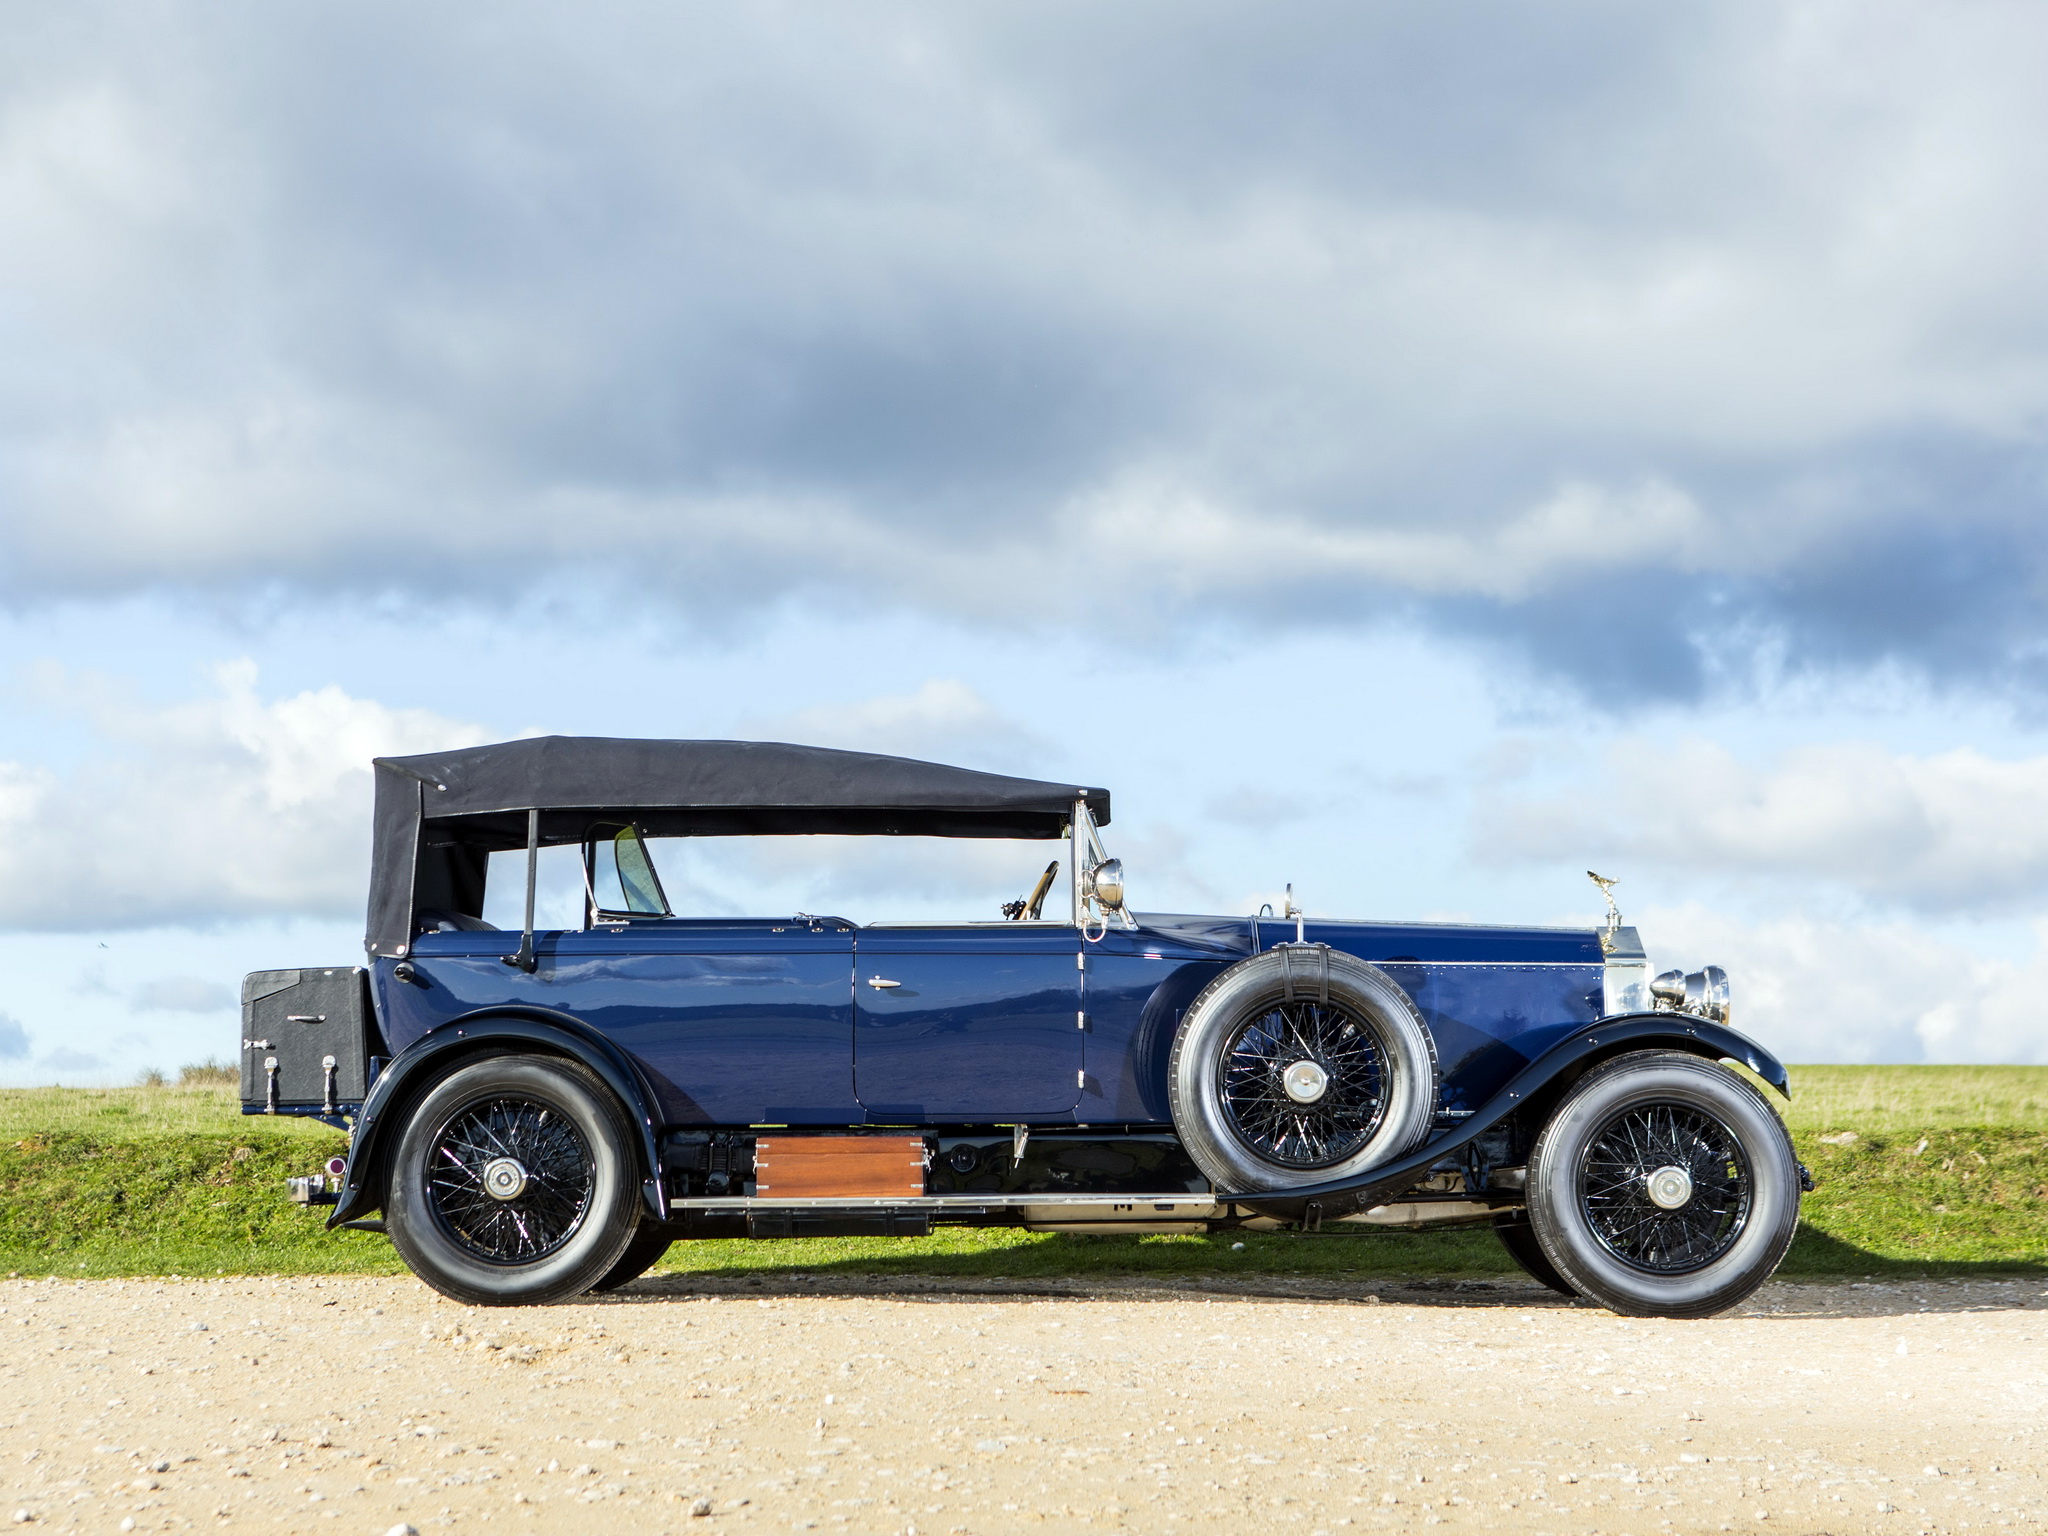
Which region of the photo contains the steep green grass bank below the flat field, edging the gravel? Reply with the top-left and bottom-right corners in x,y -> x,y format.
0,1122 -> 2048,1278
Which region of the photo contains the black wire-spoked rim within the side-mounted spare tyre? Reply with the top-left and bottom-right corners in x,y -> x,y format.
1217,1001 -> 1389,1167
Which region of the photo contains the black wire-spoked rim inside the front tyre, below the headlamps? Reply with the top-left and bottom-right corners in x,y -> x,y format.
1577,1102 -> 1755,1274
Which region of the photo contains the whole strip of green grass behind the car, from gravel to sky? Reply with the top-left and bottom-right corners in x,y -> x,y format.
0,1067 -> 2048,1278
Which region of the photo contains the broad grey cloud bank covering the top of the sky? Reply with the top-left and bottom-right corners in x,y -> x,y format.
0,0 -> 2048,698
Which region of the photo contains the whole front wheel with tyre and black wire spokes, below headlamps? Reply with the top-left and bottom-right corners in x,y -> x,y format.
1528,1051 -> 1800,1317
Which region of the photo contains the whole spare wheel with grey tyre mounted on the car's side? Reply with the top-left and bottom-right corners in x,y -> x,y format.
1167,944 -> 1436,1194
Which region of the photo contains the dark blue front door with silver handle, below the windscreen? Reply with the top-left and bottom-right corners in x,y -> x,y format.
854,924 -> 1087,1124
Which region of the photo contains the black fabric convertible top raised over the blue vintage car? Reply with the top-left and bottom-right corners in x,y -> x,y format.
365,735 -> 1110,954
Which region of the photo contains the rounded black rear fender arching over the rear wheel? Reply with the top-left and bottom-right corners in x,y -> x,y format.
328,1012 -> 670,1231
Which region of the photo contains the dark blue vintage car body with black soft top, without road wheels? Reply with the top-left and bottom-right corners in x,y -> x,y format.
260,737 -> 1786,1269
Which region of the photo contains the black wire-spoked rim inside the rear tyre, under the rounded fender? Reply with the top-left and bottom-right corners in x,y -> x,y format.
426,1098 -> 596,1264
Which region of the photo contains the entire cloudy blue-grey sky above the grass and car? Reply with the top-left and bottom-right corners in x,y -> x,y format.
0,0 -> 2048,1083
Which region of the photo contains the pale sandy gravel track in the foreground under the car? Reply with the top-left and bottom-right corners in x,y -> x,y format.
0,1276 -> 2048,1536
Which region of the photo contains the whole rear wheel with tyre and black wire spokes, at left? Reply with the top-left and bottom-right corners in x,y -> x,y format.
385,1055 -> 638,1307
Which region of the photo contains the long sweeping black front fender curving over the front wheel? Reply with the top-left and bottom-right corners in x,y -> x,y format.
1217,1014 -> 1792,1227
